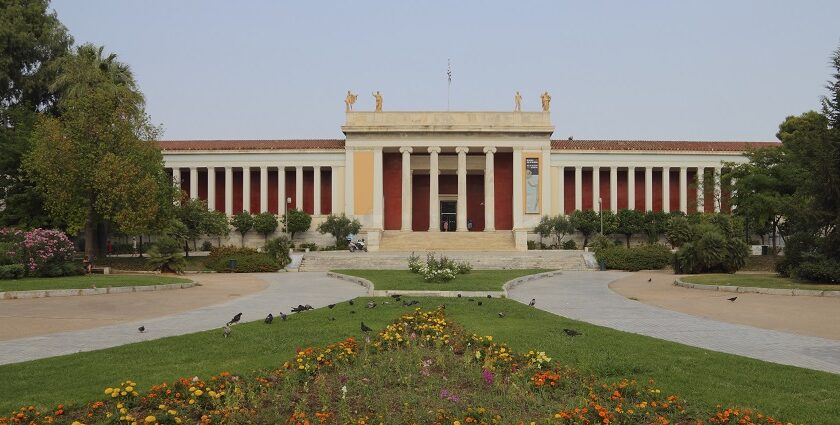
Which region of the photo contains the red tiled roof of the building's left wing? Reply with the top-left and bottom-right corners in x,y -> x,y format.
158,139 -> 344,151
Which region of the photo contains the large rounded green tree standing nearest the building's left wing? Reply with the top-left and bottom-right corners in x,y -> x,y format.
23,45 -> 172,256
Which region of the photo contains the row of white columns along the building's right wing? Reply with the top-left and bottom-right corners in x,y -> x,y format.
558,165 -> 722,213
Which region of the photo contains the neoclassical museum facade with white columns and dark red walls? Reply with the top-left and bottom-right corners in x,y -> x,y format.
160,111 -> 776,249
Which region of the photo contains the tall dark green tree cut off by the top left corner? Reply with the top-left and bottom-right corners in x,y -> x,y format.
0,0 -> 73,227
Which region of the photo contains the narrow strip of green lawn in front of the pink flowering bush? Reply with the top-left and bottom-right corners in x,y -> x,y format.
0,274 -> 190,291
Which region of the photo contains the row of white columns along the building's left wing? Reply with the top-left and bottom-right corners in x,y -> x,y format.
172,165 -> 336,216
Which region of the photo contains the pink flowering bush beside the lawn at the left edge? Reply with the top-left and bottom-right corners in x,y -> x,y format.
0,228 -> 75,276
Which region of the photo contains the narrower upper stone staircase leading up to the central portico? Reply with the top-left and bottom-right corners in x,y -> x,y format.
379,230 -> 516,252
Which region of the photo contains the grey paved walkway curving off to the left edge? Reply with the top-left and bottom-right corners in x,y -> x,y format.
0,273 -> 367,364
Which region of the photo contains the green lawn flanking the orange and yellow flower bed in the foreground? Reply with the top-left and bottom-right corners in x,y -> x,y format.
0,298 -> 840,424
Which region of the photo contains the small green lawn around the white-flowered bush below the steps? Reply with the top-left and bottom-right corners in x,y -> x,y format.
333,269 -> 549,291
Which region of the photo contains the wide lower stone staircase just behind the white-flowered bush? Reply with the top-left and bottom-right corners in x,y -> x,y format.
299,250 -> 593,272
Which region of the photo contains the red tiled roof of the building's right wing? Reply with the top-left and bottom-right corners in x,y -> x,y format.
551,140 -> 782,152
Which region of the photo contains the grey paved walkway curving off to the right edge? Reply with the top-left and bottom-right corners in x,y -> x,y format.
509,272 -> 840,373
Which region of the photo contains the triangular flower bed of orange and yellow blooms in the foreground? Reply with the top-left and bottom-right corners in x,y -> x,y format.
0,309 -> 796,425
